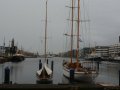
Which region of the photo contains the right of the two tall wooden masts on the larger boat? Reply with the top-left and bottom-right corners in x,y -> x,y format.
76,0 -> 80,68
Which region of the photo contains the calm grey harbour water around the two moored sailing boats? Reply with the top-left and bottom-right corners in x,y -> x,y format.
0,57 -> 120,85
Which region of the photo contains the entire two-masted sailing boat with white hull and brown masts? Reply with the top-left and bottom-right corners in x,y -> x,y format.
63,0 -> 98,82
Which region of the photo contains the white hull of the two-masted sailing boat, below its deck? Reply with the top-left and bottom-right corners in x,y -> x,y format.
63,67 -> 98,81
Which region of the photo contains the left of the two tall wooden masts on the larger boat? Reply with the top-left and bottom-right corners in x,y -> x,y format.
70,0 -> 74,63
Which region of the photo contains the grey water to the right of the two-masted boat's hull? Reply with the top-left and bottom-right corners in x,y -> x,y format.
95,62 -> 120,85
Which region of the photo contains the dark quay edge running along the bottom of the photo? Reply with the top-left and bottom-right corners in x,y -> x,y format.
0,84 -> 120,90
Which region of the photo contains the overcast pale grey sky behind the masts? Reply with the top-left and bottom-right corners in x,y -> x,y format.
0,0 -> 120,53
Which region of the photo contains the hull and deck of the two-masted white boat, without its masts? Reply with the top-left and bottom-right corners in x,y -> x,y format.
63,62 -> 98,82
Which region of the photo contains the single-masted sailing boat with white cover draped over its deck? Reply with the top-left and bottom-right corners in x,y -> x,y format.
36,1 -> 52,83
